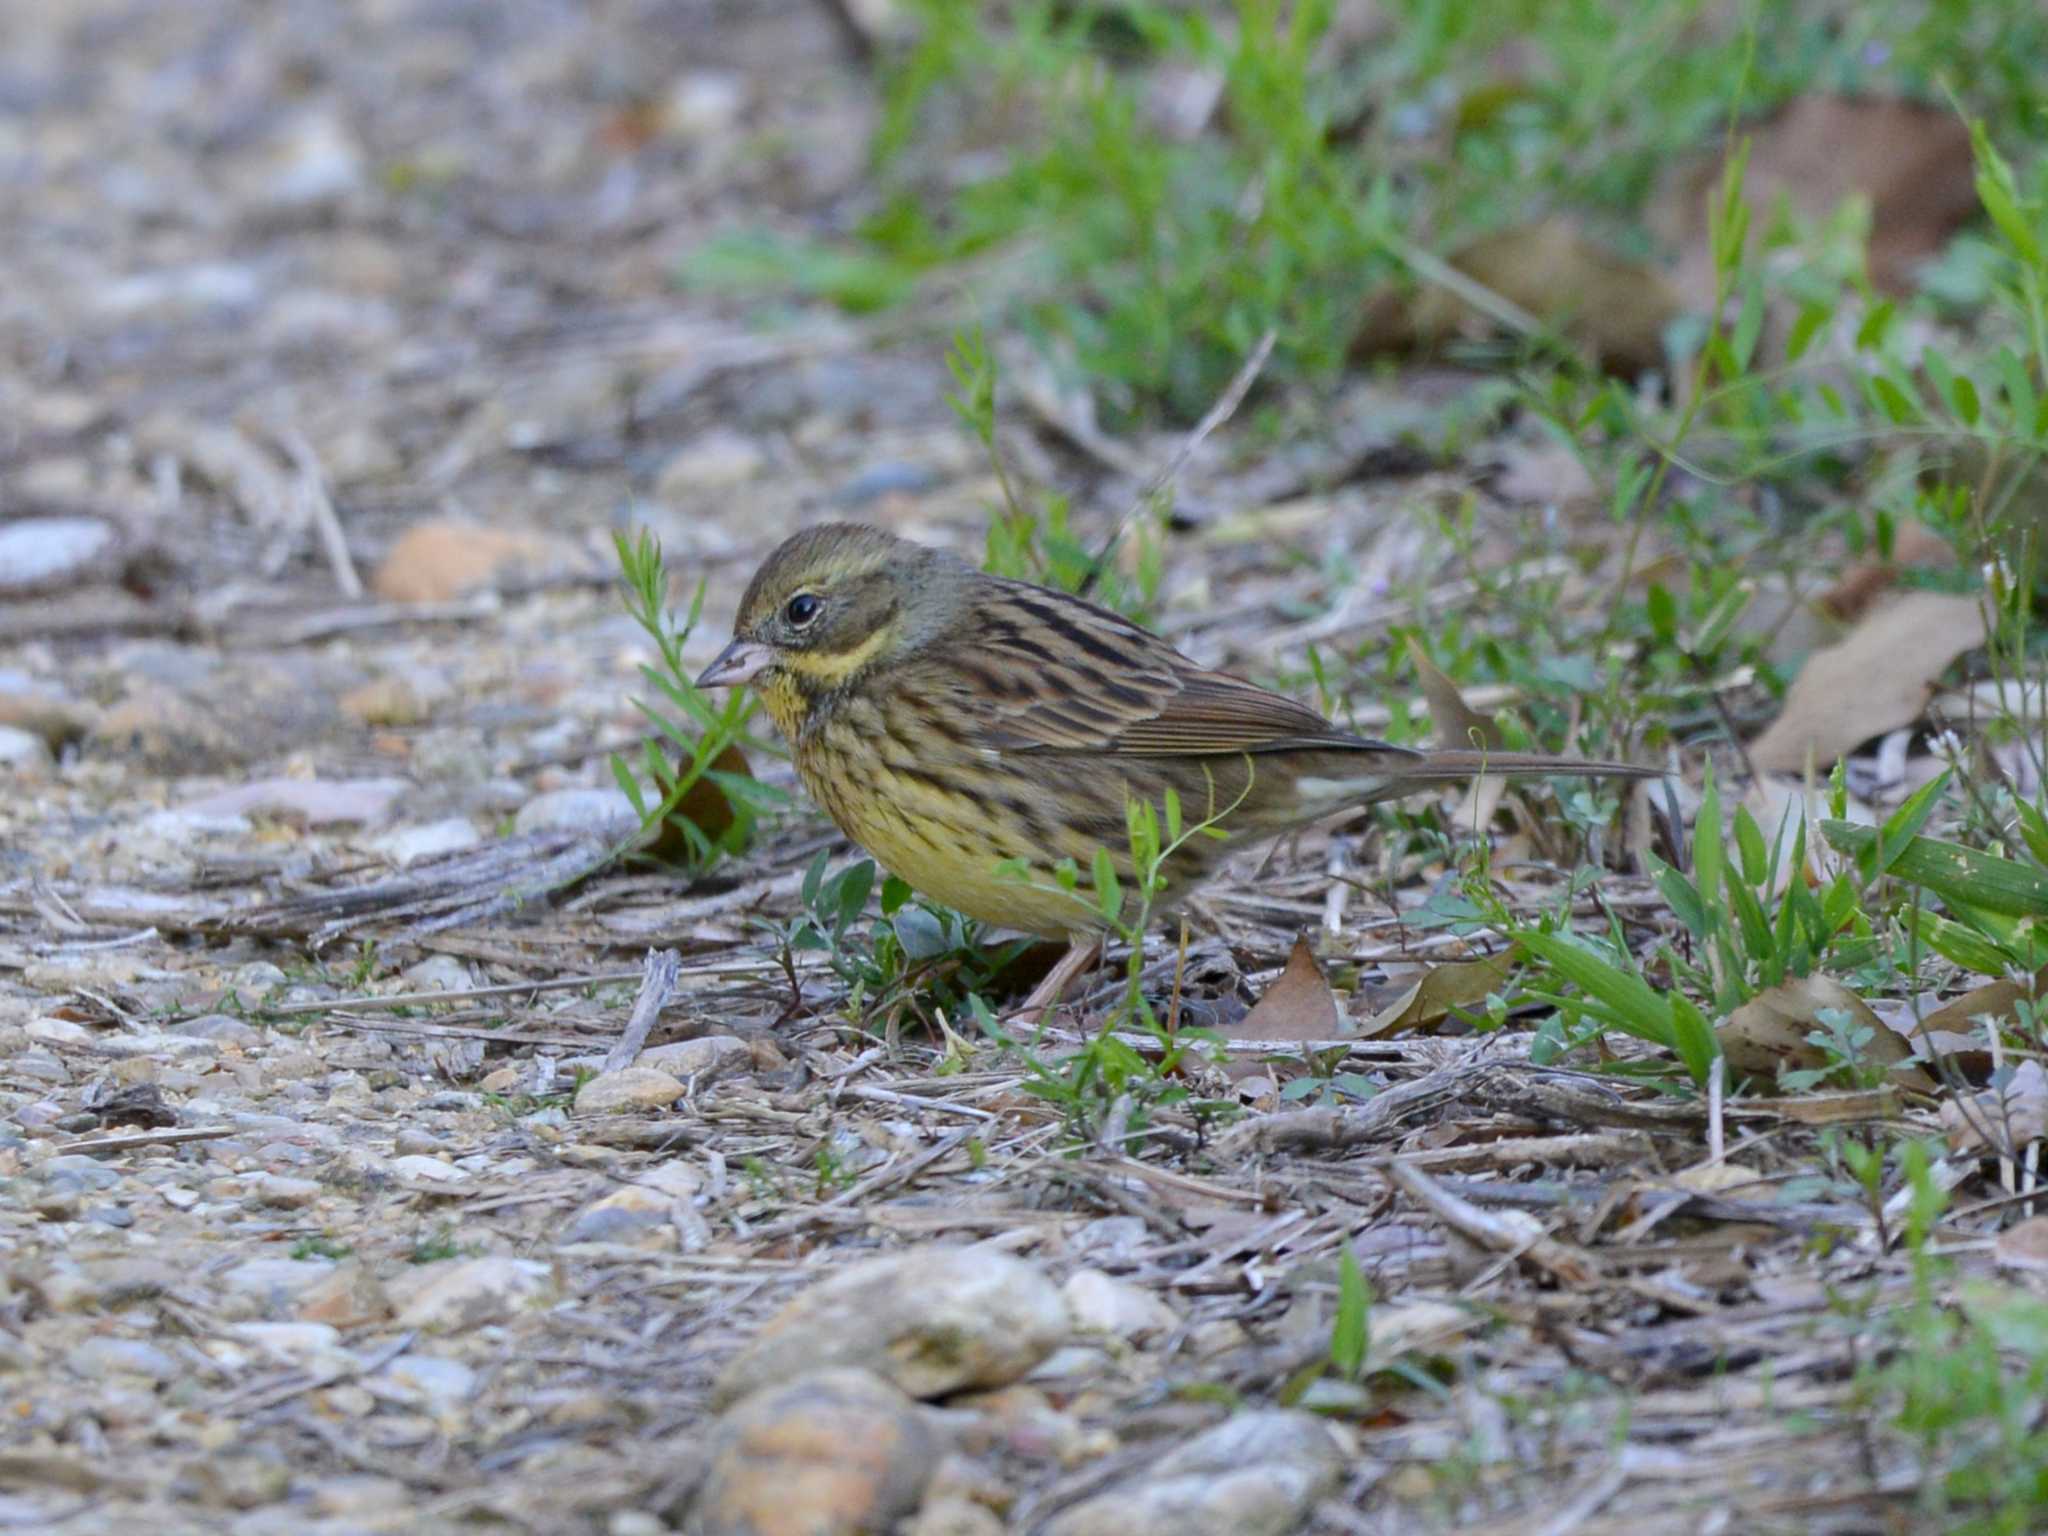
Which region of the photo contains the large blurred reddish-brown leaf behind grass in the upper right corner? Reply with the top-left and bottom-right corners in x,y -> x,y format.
1653,92 -> 1976,307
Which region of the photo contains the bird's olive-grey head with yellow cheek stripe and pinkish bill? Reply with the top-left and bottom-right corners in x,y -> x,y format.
696,522 -> 969,727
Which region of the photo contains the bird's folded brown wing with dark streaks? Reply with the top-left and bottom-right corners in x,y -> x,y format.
946,582 -> 1397,756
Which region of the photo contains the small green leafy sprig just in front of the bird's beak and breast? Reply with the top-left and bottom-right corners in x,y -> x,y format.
612,528 -> 784,866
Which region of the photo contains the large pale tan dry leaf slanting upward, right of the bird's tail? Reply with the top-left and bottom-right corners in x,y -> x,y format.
1749,592 -> 1985,774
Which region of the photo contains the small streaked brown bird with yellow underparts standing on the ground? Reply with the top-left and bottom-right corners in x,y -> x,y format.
696,522 -> 1659,1016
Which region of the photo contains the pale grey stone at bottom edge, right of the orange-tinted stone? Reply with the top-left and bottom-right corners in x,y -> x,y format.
1044,1409 -> 1348,1536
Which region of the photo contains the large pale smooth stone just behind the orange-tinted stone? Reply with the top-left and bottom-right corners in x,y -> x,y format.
713,1247 -> 1073,1403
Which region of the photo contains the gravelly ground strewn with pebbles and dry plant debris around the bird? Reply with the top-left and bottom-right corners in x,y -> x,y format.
0,0 -> 2048,1536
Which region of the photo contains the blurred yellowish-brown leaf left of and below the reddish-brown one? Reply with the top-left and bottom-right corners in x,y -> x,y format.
1354,217 -> 1683,375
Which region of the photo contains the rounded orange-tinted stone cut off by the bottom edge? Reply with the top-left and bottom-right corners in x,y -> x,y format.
684,1370 -> 940,1536
